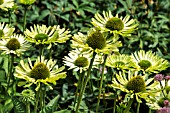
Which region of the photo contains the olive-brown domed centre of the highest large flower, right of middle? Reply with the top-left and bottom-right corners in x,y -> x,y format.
105,17 -> 124,31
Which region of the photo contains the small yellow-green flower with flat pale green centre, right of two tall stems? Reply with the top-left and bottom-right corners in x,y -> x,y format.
106,54 -> 134,70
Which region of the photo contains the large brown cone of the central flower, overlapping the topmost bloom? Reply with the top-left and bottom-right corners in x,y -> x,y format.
86,31 -> 106,49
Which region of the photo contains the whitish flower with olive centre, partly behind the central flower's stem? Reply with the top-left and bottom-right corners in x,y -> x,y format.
63,49 -> 102,73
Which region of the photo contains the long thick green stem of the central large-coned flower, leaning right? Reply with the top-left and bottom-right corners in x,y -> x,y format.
75,51 -> 96,113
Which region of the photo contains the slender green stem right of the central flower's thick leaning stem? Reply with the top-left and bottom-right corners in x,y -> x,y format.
96,55 -> 107,113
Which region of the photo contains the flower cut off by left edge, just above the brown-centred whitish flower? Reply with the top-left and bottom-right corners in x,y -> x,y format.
0,22 -> 15,38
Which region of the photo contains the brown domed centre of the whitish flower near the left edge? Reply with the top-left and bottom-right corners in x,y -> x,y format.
6,38 -> 21,50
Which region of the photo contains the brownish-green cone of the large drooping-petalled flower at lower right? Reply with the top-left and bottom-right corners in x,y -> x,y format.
126,76 -> 146,93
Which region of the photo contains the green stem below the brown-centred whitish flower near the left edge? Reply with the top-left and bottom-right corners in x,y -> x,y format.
7,54 -> 14,91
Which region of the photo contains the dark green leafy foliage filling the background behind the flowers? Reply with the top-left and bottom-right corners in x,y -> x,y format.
0,0 -> 170,113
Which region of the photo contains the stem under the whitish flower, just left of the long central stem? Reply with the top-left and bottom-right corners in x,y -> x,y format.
74,71 -> 85,107
